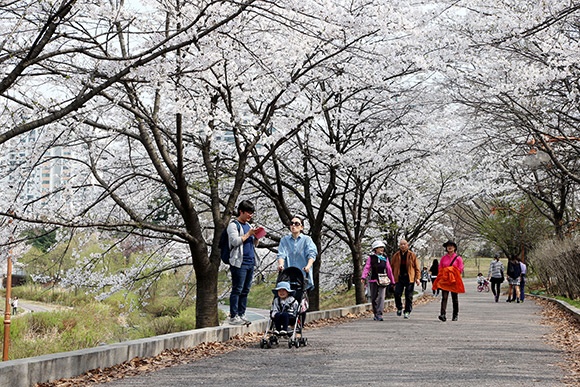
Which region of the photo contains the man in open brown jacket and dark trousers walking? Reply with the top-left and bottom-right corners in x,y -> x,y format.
391,239 -> 421,318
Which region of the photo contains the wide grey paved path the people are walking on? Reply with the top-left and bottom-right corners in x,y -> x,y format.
107,280 -> 564,387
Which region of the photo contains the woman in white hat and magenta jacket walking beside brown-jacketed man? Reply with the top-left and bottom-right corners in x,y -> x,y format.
361,241 -> 395,321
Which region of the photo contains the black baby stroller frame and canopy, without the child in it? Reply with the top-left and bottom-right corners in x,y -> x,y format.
260,267 -> 308,348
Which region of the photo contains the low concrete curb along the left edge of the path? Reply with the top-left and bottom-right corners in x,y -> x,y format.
0,296 -> 386,387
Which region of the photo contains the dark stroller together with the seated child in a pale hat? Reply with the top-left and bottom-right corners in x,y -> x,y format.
260,267 -> 308,348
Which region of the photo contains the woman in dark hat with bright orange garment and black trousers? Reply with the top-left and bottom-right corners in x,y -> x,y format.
433,241 -> 465,321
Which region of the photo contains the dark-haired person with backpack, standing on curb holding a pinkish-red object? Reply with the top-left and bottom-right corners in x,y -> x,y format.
227,200 -> 258,325
